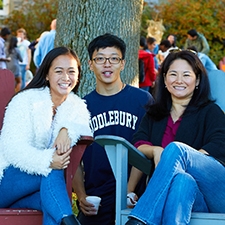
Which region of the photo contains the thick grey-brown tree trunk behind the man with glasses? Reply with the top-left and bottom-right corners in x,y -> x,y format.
55,0 -> 143,97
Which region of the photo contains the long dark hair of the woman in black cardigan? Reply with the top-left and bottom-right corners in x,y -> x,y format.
147,50 -> 210,120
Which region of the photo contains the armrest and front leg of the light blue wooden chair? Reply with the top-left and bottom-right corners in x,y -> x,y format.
95,135 -> 153,225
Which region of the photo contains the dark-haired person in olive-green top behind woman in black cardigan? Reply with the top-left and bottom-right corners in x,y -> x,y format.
183,29 -> 210,55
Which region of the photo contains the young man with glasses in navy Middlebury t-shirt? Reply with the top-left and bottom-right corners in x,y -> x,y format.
73,34 -> 153,225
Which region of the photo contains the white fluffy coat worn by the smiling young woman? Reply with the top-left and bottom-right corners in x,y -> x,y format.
0,88 -> 92,181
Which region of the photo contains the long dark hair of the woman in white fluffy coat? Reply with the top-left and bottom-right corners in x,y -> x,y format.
23,47 -> 81,93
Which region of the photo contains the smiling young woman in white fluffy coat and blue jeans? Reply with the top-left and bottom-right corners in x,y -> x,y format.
0,47 -> 92,225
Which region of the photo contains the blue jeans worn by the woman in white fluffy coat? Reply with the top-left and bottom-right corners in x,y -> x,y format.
0,166 -> 73,225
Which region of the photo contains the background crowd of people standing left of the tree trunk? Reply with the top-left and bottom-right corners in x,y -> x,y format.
0,19 -> 56,93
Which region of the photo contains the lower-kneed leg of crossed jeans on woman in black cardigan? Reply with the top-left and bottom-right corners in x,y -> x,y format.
161,173 -> 208,225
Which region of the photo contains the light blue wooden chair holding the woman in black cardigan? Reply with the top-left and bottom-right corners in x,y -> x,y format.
95,70 -> 225,225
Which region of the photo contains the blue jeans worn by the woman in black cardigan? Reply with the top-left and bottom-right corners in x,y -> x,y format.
129,142 -> 225,225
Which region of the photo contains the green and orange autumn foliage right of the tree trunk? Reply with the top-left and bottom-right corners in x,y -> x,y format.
142,0 -> 225,65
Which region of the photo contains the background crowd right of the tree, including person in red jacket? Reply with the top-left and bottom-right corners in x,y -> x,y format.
135,29 -> 218,94
